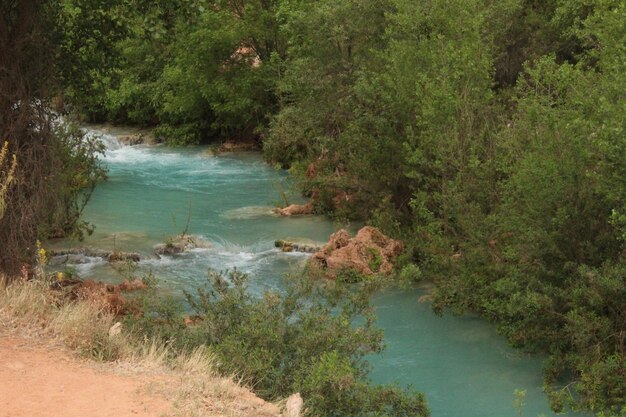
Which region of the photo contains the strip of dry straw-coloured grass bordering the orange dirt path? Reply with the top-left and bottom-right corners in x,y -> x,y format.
0,276 -> 280,417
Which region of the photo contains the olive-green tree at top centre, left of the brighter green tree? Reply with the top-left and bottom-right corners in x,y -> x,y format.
264,0 -> 390,166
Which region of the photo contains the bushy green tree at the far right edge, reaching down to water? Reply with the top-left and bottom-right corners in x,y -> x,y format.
431,1 -> 626,415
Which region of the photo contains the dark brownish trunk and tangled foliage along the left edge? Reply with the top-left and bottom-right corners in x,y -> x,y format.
0,1 -> 104,274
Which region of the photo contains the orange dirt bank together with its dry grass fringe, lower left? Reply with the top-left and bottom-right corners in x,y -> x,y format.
0,279 -> 280,417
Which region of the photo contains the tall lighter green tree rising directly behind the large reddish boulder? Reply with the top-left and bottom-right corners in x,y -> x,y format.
338,1 -> 492,219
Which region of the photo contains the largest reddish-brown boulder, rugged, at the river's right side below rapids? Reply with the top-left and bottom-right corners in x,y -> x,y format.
311,226 -> 403,279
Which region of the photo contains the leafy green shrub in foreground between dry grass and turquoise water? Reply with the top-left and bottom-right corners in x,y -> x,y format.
129,270 -> 429,417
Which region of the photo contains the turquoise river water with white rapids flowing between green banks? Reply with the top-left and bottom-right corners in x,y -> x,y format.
59,127 -> 572,417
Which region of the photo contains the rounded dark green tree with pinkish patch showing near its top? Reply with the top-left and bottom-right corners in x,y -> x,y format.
155,2 -> 280,143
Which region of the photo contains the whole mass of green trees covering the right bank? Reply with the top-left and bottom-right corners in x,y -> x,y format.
265,0 -> 626,415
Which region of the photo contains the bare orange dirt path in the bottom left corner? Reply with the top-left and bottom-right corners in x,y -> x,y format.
0,336 -> 170,417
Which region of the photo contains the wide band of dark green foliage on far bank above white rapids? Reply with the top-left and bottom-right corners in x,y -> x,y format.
64,0 -> 286,144
